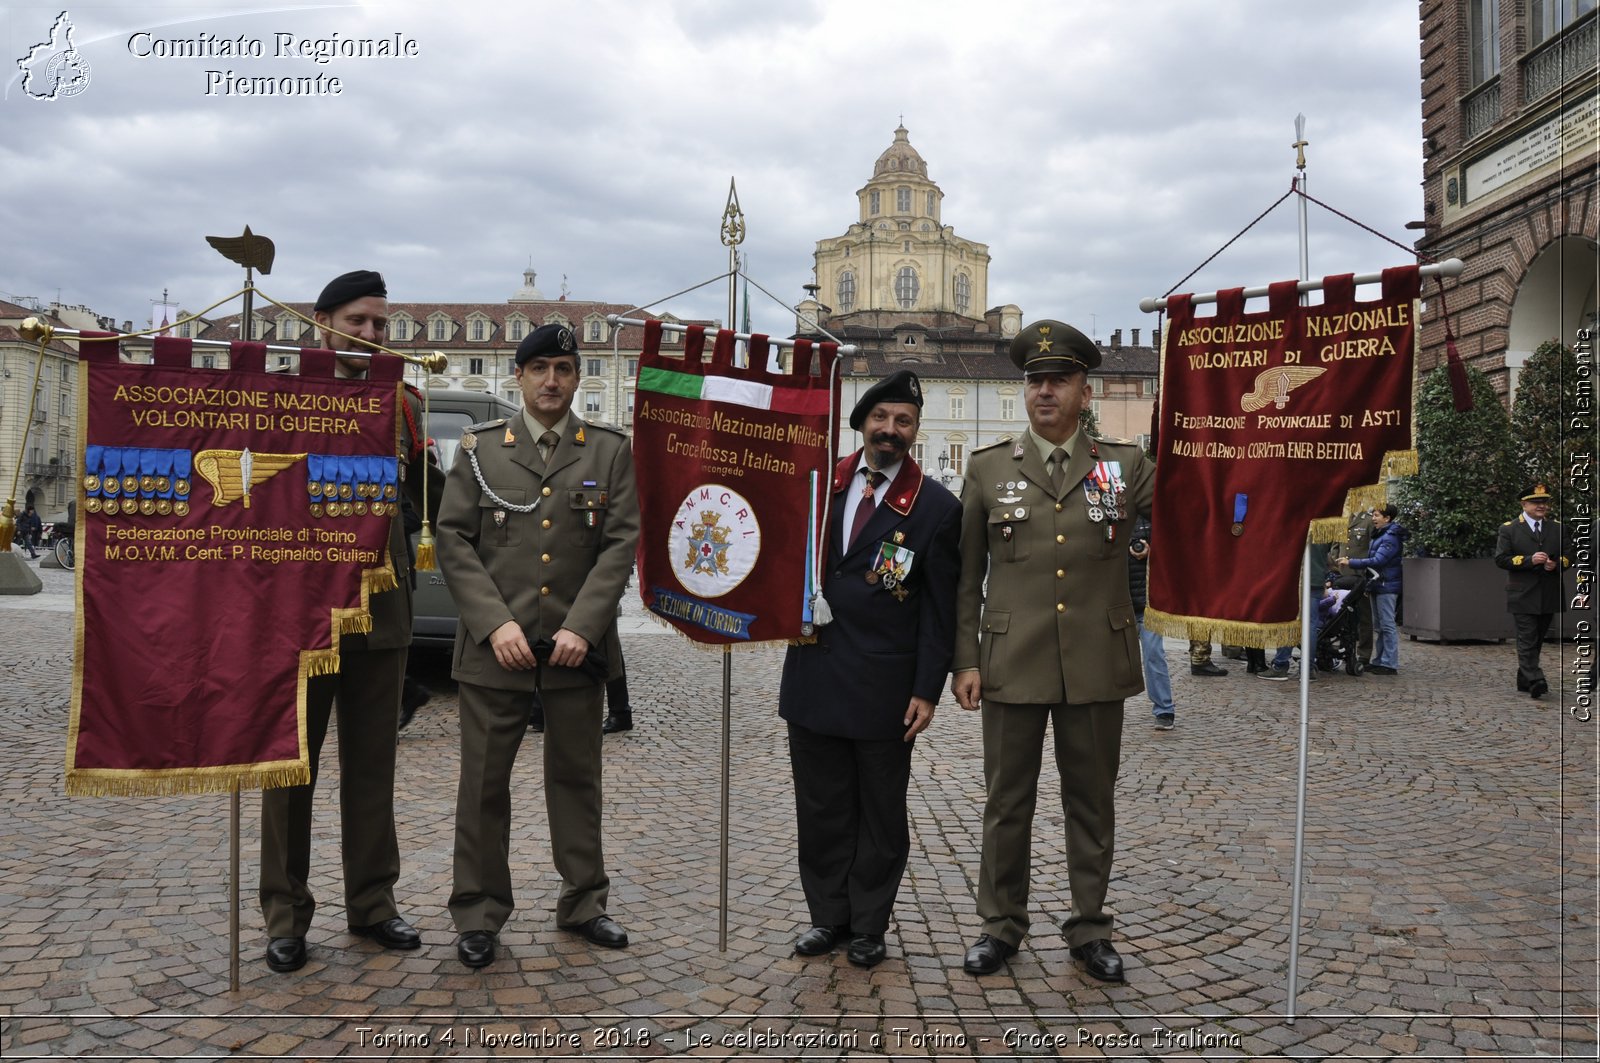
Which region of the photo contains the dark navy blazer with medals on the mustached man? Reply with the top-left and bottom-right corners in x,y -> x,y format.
778,450 -> 962,741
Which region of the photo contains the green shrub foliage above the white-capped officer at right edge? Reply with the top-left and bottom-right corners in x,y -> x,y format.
1510,339 -> 1586,520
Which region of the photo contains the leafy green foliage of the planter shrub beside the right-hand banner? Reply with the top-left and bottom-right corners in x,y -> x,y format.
1395,365 -> 1523,557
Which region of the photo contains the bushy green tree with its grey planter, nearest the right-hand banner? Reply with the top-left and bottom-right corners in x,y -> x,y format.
1395,367 -> 1522,642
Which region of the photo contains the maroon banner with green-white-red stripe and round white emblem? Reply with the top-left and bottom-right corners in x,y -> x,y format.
634,322 -> 838,644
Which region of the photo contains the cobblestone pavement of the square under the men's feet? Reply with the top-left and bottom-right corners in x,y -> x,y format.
0,550 -> 1597,1060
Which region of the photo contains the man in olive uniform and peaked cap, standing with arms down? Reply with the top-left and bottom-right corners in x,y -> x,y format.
954,320 -> 1155,981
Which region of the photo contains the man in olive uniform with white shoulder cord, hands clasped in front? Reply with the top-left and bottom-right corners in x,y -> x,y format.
438,325 -> 638,967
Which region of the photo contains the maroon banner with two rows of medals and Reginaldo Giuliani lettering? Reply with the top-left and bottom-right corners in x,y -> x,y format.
67,339 -> 400,794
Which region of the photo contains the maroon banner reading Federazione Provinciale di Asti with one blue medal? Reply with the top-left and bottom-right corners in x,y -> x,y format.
1146,266 -> 1421,647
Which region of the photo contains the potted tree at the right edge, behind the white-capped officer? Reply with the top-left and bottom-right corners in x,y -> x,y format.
1510,339 -> 1594,639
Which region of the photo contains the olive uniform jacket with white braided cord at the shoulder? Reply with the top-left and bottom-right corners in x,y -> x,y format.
438,416 -> 638,690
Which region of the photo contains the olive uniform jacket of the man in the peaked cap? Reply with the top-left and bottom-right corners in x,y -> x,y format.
955,429 -> 1155,704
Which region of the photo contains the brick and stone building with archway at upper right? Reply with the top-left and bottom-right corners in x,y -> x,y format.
1418,0 -> 1600,402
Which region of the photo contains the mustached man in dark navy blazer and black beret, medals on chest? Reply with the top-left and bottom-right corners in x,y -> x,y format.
778,370 -> 962,967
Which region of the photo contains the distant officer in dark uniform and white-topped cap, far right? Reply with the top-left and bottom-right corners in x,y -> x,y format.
1494,483 -> 1573,698
